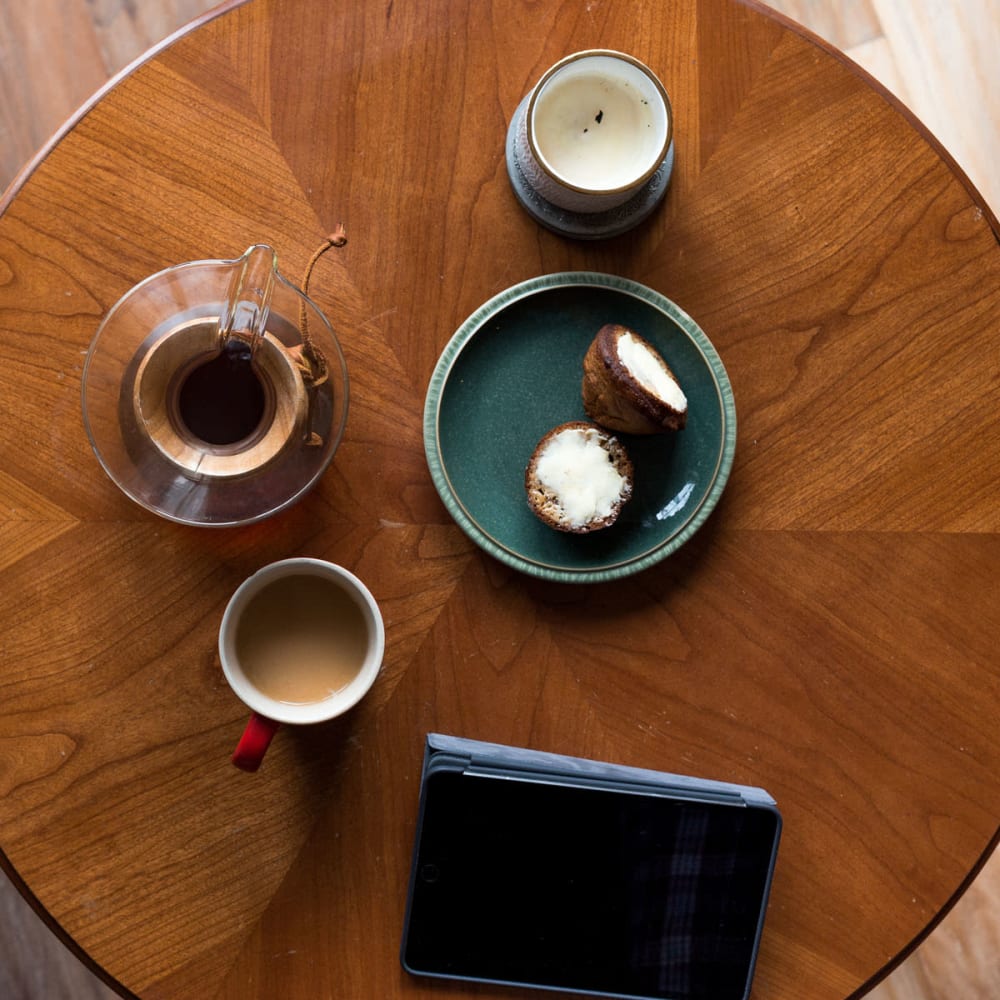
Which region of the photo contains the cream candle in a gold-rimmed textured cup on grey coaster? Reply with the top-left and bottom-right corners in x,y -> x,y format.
511,49 -> 673,213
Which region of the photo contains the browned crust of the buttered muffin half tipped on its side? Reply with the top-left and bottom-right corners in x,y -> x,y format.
583,323 -> 687,434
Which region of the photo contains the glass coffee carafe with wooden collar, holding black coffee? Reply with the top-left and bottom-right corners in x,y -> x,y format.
83,245 -> 348,526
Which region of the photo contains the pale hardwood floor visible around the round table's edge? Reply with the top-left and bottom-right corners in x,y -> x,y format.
0,0 -> 1000,1000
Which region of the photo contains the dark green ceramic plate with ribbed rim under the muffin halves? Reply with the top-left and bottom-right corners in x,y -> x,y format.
424,272 -> 736,583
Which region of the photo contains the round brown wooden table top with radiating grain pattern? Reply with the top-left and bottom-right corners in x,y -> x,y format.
0,0 -> 1000,1000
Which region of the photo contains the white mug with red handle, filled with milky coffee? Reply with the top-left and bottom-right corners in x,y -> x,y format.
219,558 -> 385,771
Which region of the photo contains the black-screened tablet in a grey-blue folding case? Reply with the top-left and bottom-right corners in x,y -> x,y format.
401,734 -> 781,1000
